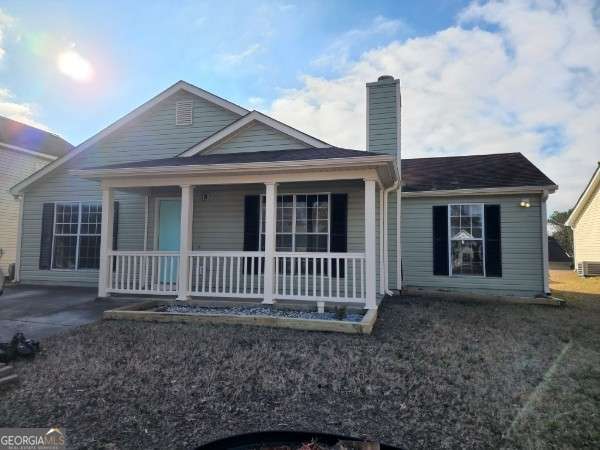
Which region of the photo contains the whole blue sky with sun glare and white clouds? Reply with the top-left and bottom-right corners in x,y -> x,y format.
0,0 -> 600,212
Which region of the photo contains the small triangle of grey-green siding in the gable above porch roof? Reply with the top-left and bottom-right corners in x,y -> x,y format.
204,122 -> 310,154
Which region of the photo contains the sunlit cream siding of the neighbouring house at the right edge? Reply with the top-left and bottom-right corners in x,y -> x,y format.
573,188 -> 600,267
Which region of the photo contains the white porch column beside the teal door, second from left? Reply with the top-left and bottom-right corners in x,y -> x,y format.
177,184 -> 194,300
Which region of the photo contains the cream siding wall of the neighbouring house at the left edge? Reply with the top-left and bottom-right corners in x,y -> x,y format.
0,147 -> 50,275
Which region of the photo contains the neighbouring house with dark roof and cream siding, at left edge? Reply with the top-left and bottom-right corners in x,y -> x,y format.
0,116 -> 73,276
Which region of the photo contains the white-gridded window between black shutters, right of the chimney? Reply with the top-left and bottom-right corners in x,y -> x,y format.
448,204 -> 485,275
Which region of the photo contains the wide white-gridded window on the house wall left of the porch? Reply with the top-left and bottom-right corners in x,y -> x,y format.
52,202 -> 102,270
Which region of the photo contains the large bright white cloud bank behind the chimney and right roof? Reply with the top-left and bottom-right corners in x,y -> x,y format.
270,0 -> 600,213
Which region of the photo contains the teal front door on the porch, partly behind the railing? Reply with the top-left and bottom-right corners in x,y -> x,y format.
158,198 -> 181,283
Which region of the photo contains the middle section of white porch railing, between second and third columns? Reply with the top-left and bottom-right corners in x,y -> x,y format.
188,252 -> 265,298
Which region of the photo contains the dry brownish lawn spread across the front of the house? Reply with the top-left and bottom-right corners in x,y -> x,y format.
0,282 -> 600,448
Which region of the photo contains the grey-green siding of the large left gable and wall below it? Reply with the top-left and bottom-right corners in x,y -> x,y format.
21,91 -> 238,285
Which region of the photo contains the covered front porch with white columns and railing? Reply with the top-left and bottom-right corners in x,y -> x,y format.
77,151 -> 395,309
